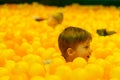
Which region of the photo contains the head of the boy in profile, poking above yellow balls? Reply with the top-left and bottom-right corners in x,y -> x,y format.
58,26 -> 92,62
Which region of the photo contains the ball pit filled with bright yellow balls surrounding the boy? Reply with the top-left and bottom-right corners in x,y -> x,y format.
0,3 -> 120,80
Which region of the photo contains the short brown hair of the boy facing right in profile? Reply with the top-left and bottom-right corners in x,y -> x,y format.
58,26 -> 92,59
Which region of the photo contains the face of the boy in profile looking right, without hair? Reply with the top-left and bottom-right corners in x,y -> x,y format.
72,39 -> 91,61
